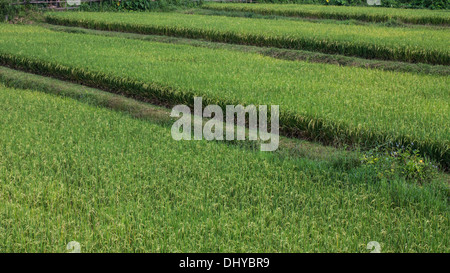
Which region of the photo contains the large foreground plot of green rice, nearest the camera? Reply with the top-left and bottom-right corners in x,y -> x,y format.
0,85 -> 450,253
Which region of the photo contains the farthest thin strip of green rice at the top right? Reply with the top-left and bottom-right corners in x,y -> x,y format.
202,3 -> 450,25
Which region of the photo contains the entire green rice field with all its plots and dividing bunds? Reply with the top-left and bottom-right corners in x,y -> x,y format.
0,4 -> 450,253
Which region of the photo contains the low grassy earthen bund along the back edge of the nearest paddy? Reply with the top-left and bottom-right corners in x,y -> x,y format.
0,66 -> 362,165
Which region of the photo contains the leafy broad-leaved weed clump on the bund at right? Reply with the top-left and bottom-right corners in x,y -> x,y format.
361,143 -> 438,184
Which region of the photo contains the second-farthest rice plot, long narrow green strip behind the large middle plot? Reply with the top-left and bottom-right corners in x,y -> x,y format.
46,12 -> 450,65
